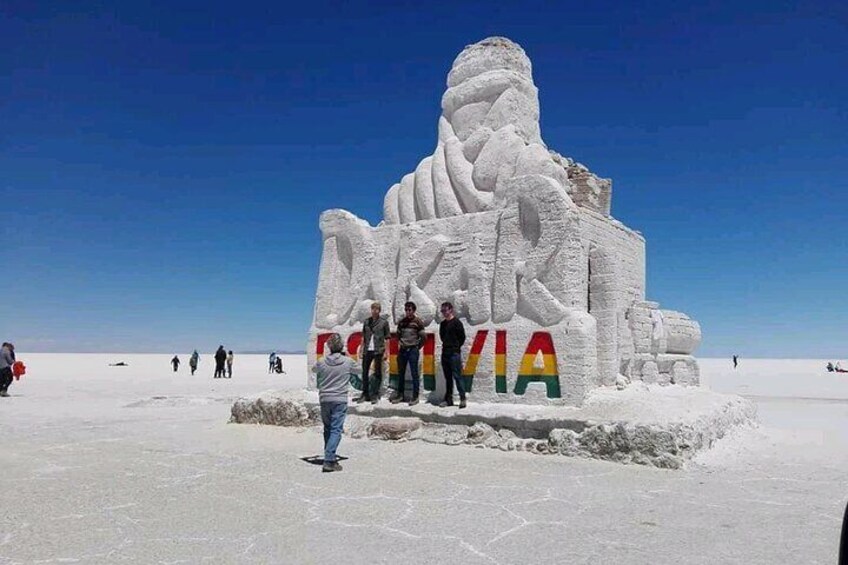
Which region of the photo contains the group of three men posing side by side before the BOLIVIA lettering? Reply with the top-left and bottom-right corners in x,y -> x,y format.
356,302 -> 465,408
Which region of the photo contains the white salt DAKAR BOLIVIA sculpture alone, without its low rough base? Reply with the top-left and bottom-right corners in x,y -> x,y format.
308,37 -> 701,406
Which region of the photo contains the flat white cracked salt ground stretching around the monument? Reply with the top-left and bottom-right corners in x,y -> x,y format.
0,355 -> 848,565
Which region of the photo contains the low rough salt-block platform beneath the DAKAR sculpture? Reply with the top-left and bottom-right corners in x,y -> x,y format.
230,383 -> 756,469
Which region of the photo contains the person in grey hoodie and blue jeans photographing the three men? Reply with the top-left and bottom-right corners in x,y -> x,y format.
315,334 -> 357,473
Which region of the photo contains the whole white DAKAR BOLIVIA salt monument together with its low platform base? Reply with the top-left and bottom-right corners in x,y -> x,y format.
231,37 -> 755,467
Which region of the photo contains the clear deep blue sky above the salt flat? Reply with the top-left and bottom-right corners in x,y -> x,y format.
0,0 -> 848,359
